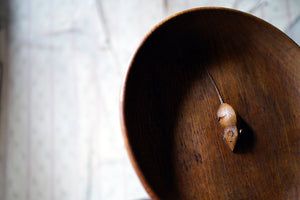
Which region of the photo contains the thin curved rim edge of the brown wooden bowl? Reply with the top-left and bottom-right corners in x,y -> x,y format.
119,6 -> 299,199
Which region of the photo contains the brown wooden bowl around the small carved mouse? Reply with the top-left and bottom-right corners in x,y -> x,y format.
120,8 -> 300,199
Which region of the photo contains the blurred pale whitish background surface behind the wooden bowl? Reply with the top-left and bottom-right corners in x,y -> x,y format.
0,0 -> 300,200
